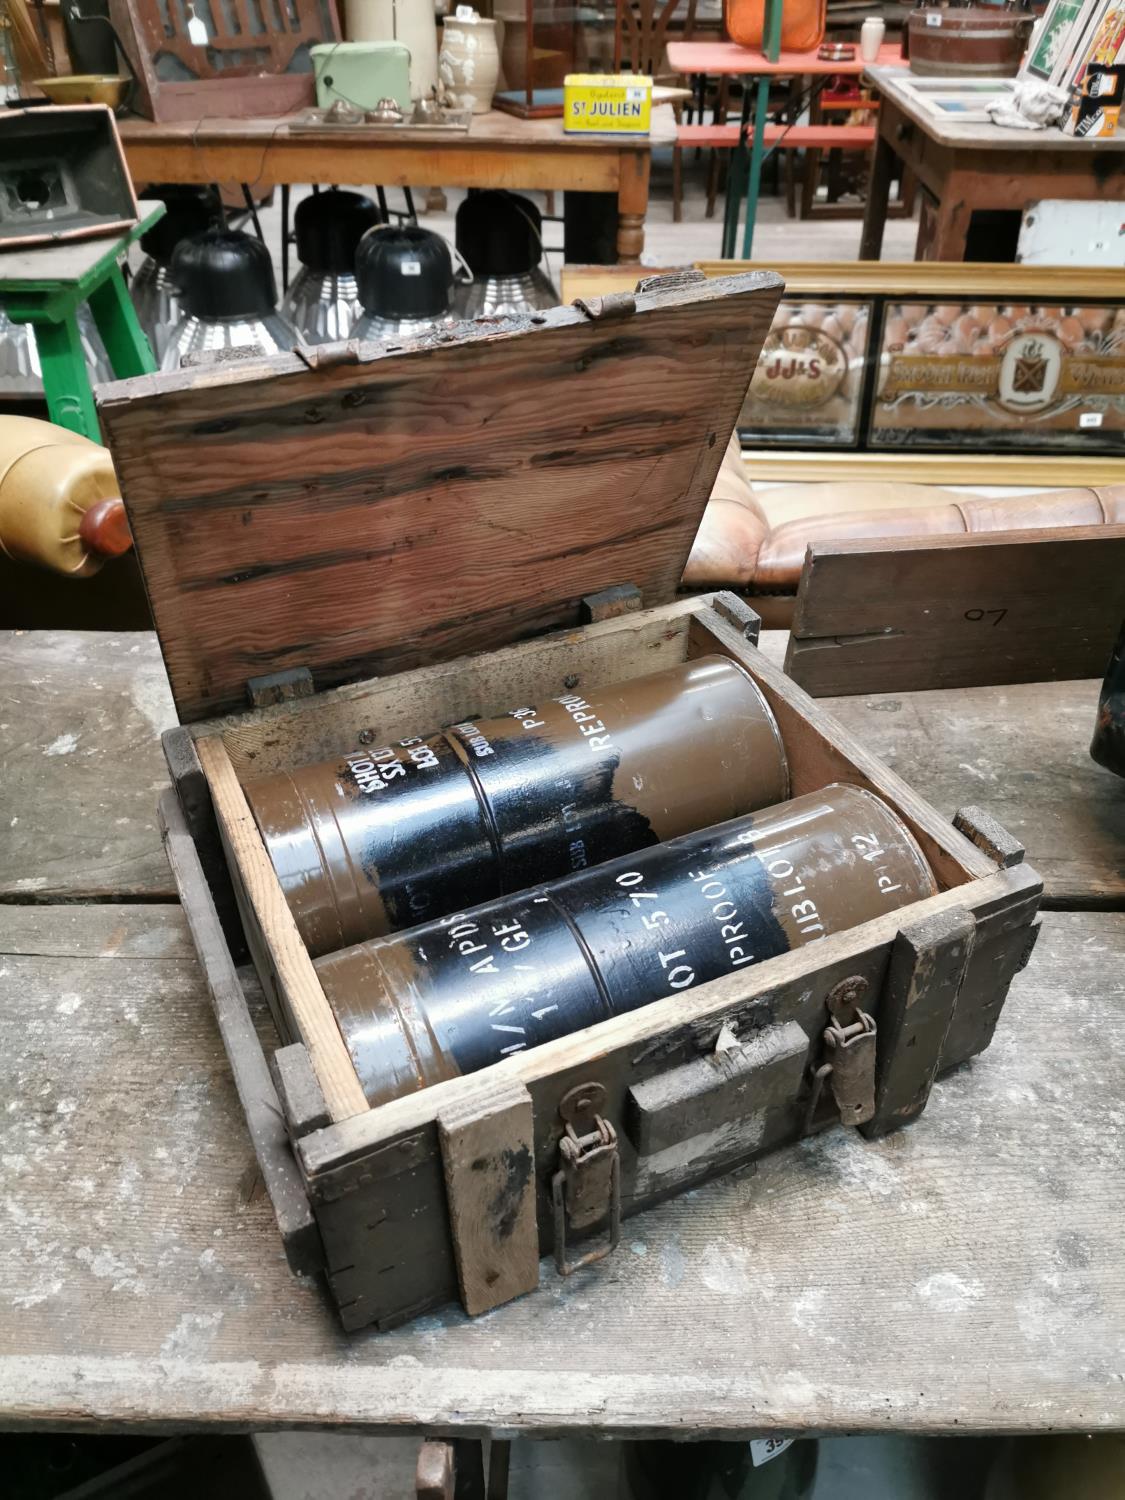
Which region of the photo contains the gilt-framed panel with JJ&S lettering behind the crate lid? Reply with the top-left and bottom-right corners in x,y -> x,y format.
693,261 -> 1125,464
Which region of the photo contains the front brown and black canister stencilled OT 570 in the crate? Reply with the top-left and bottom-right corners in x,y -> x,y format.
317,785 -> 938,1104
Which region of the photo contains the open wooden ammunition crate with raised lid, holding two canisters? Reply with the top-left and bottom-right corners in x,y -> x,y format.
102,276 -> 1041,1329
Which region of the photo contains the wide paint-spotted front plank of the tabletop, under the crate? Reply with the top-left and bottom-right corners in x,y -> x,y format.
0,908 -> 1125,1437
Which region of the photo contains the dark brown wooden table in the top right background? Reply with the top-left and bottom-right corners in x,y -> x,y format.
860,66 -> 1125,261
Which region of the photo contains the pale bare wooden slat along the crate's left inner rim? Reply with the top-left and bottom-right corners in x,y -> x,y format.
197,740 -> 368,1121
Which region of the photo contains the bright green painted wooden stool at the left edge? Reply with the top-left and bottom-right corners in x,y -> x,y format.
0,201 -> 165,443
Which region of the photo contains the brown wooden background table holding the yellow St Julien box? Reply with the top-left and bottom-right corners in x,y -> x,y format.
120,105 -> 675,264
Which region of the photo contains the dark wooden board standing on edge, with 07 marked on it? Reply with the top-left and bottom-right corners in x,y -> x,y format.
785,527 -> 1125,698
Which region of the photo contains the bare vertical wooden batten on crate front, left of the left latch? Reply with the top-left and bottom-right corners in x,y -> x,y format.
438,1085 -> 539,1314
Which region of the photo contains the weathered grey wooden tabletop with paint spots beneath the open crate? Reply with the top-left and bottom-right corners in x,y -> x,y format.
0,633 -> 1125,1436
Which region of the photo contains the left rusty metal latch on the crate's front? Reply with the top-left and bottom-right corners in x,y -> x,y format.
551,1083 -> 621,1277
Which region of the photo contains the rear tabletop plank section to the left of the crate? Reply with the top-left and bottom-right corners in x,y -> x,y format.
0,627 -> 176,902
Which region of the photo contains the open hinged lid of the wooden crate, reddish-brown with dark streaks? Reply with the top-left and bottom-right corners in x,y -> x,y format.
98,273 -> 782,723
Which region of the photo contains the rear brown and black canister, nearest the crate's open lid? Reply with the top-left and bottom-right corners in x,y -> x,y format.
246,657 -> 789,956
